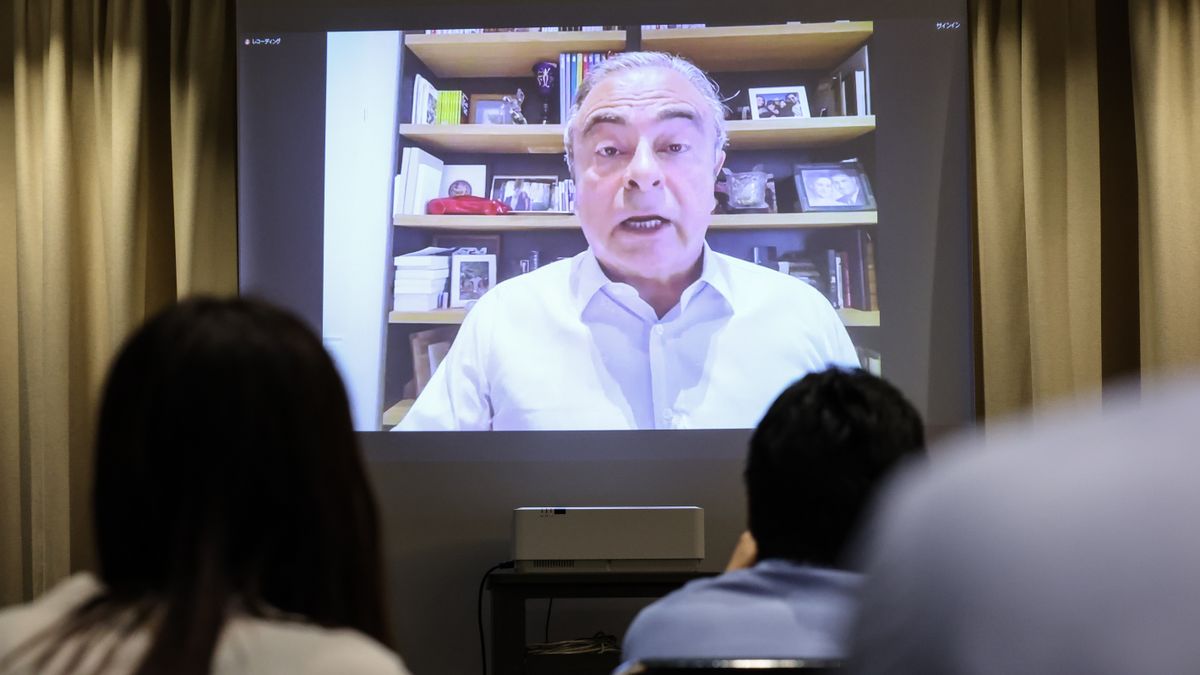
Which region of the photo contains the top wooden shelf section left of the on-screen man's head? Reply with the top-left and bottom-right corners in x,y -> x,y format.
404,30 -> 625,77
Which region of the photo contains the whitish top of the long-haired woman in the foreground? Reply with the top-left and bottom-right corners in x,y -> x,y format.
0,574 -> 408,675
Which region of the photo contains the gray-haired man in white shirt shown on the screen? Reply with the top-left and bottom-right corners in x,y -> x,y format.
397,52 -> 858,430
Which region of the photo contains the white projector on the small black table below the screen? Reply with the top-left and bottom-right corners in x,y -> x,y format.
512,507 -> 704,572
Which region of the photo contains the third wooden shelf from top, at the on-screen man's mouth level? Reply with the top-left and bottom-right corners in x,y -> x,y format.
392,211 -> 878,232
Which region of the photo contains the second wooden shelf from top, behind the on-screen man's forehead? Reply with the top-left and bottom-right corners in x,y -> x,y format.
400,115 -> 875,155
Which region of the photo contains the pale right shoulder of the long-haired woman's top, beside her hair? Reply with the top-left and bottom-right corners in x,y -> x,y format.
214,616 -> 408,675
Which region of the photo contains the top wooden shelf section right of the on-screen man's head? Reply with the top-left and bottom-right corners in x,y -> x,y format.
642,22 -> 875,72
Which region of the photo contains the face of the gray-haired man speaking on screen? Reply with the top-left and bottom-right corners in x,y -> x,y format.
572,67 -> 725,279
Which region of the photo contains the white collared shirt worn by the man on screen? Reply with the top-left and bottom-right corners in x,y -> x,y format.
396,244 -> 858,430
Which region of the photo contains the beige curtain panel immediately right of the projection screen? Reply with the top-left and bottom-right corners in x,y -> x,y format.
971,0 -> 1102,419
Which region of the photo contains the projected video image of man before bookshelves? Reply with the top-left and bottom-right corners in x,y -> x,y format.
324,22 -> 887,431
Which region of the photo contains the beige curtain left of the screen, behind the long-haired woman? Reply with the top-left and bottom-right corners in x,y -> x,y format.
0,0 -> 236,602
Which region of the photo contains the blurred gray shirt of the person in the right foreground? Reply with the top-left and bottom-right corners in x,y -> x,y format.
852,383 -> 1200,675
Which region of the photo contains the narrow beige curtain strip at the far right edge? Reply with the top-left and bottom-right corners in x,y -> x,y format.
1129,0 -> 1200,377
